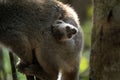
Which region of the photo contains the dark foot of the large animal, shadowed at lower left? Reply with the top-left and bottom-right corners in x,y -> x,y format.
17,63 -> 50,80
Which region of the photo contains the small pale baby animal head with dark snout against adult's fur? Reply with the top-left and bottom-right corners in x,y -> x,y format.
52,20 -> 78,41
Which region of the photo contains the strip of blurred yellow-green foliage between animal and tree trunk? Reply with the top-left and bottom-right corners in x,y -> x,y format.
80,6 -> 93,80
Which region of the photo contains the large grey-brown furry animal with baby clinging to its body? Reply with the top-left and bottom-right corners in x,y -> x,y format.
0,0 -> 83,80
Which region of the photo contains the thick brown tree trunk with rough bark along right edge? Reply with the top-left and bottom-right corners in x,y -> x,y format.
90,0 -> 120,80
